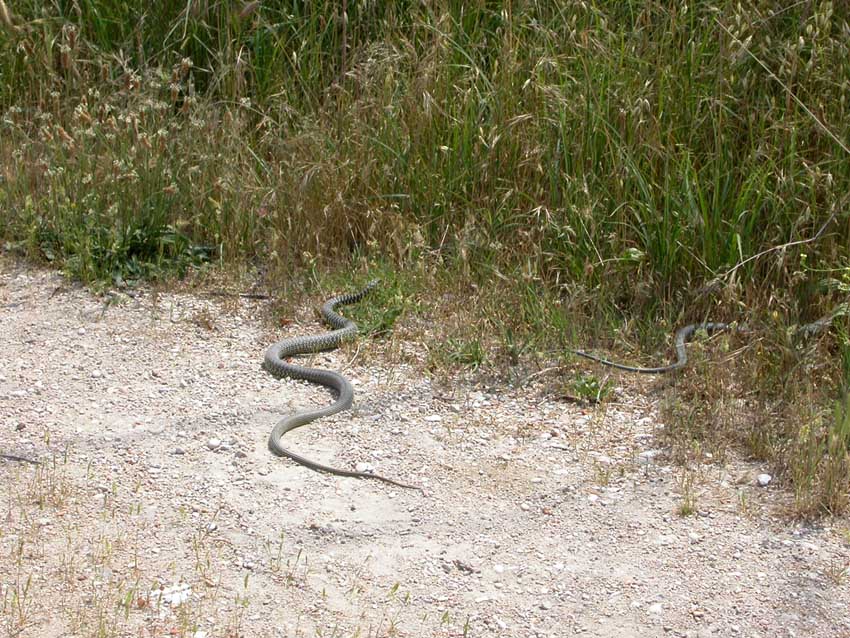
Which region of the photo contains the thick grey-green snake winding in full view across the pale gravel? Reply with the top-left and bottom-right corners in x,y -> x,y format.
263,280 -> 422,491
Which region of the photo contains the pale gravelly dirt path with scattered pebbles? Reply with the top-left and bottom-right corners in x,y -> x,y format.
0,264 -> 850,638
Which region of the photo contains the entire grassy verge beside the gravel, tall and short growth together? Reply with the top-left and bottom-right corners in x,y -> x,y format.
0,0 -> 850,512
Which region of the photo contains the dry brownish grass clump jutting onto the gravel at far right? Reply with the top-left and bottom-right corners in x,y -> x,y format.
662,320 -> 850,519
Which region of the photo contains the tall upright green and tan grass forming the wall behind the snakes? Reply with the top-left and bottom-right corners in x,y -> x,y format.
0,0 -> 850,310
